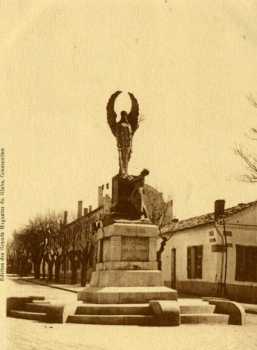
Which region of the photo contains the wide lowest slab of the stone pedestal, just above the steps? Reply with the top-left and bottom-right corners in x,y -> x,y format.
78,286 -> 177,304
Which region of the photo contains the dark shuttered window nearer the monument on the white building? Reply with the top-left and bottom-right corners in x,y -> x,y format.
187,245 -> 203,279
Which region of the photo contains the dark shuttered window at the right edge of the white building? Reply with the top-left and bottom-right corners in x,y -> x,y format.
236,245 -> 257,282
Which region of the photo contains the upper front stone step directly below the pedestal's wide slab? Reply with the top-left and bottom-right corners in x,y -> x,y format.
75,304 -> 152,315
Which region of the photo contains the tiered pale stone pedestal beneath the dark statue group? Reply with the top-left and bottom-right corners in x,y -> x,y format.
78,220 -> 177,304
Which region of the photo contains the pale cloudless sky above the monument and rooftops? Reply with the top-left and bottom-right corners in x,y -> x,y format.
0,0 -> 257,238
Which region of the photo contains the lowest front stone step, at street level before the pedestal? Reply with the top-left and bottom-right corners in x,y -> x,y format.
67,315 -> 154,326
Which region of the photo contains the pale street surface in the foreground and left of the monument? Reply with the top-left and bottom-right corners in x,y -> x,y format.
1,280 -> 257,350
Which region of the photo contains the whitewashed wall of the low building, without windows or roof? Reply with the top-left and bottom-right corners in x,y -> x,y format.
162,204 -> 257,302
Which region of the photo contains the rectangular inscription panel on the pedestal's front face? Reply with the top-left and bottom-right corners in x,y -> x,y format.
121,236 -> 149,261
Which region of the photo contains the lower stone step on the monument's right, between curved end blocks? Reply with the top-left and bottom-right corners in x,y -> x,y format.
180,313 -> 229,324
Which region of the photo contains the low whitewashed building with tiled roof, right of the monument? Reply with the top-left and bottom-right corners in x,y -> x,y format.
162,201 -> 257,303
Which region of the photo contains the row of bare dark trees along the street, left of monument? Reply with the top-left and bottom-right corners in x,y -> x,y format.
7,213 -> 94,285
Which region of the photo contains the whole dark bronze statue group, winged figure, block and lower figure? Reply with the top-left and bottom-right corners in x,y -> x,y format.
106,91 -> 149,224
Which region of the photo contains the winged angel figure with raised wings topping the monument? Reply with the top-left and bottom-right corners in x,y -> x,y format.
106,91 -> 139,179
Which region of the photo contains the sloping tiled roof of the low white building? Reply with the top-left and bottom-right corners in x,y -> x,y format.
161,201 -> 257,234
